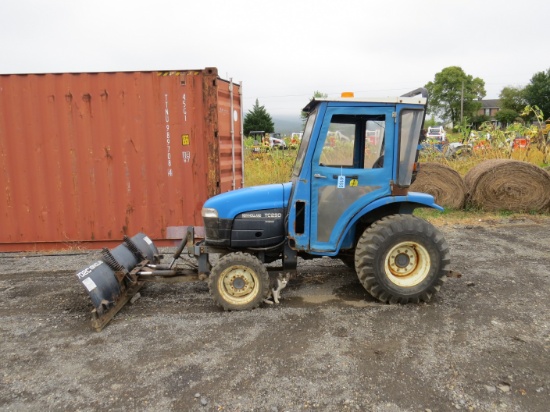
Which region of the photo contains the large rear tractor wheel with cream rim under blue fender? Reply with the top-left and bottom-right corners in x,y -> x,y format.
355,215 -> 451,303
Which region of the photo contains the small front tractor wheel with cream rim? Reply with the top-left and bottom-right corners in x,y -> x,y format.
208,252 -> 269,310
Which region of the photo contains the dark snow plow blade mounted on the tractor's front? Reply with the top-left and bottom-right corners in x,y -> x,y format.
76,233 -> 161,332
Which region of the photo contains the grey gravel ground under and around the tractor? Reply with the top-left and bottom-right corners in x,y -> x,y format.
0,219 -> 550,412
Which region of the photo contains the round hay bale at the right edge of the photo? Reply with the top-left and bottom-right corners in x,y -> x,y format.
464,159 -> 550,212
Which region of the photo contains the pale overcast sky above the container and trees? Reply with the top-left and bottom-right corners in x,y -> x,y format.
0,0 -> 550,116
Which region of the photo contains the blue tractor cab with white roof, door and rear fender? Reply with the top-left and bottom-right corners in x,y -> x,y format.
288,91 -> 433,255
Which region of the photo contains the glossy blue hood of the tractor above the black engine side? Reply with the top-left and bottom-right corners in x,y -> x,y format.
204,182 -> 292,219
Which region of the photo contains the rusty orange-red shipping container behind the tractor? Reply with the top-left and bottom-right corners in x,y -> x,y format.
0,68 -> 242,251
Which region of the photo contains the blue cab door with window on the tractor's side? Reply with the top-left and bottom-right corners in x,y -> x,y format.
309,106 -> 396,253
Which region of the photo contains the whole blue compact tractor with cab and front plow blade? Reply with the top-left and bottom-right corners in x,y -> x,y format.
77,88 -> 450,330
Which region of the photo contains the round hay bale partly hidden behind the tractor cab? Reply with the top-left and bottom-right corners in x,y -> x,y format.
410,162 -> 467,209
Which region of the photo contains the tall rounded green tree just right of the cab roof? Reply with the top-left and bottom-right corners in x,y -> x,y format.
425,66 -> 485,125
